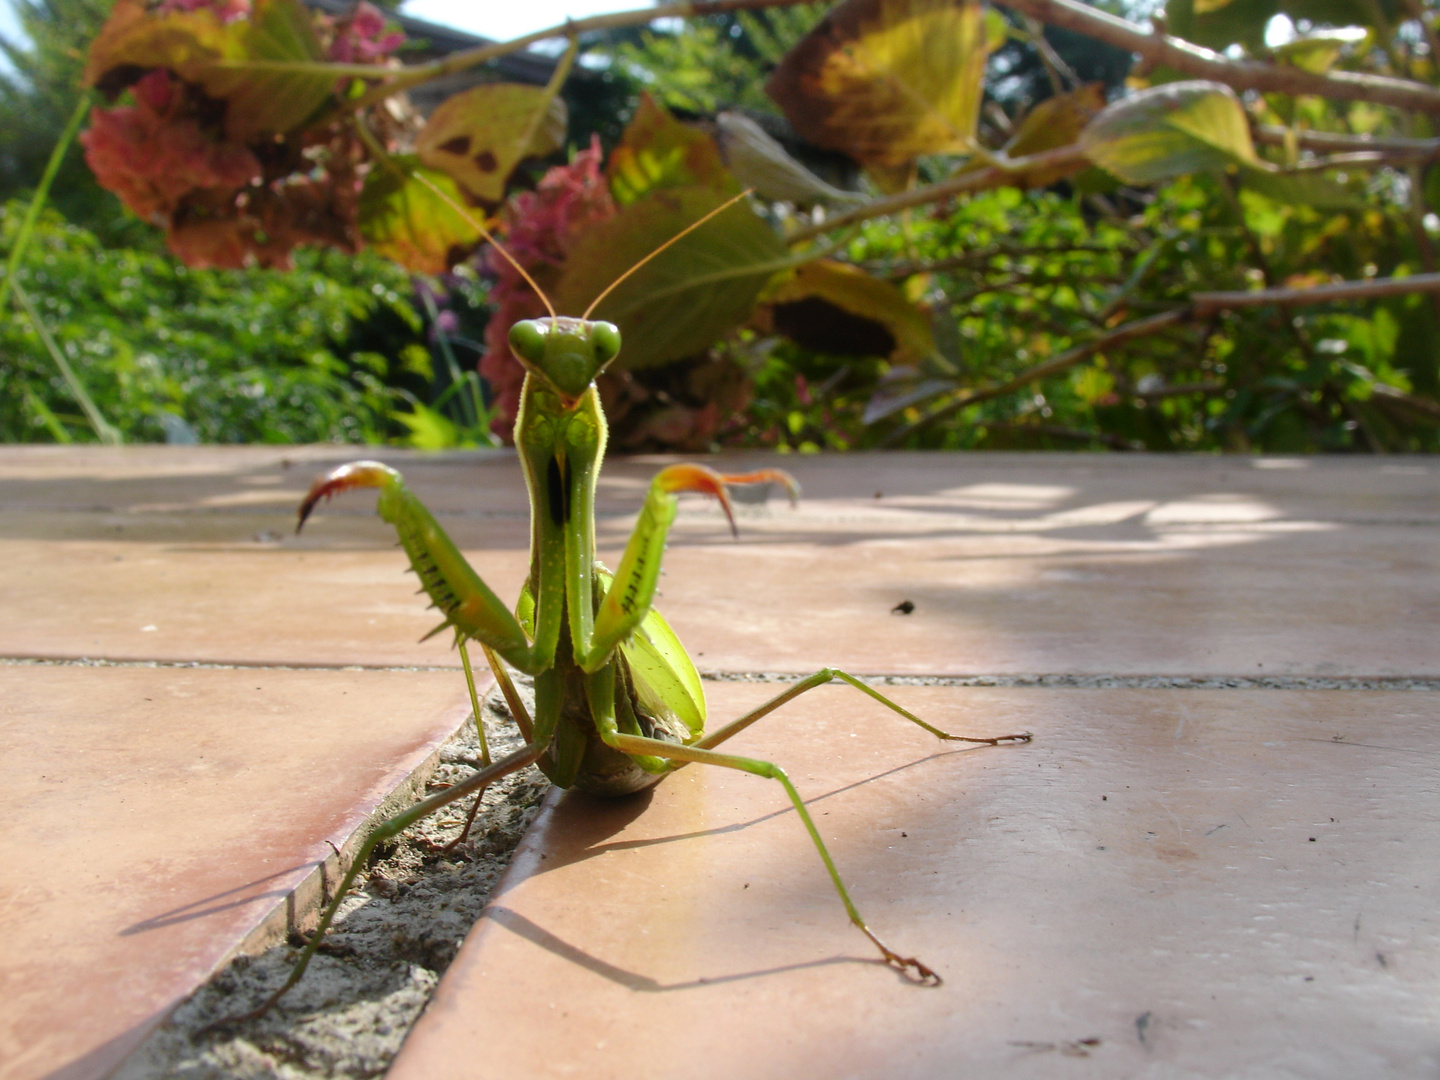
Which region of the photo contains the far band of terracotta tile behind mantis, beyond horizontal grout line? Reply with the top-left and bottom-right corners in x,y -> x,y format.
0,448 -> 1440,675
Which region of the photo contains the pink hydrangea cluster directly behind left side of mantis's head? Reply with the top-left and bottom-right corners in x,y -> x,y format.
480,135 -> 616,439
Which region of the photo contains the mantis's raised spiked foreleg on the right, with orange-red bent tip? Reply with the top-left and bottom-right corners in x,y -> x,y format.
575,465 -> 799,672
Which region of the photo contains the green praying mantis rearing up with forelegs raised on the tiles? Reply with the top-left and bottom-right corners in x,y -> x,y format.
233,194 -> 1031,1017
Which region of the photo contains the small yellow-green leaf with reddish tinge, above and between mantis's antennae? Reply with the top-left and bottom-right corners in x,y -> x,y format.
605,94 -> 740,206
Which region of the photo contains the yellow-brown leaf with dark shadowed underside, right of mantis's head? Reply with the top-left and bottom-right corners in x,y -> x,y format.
765,259 -> 935,364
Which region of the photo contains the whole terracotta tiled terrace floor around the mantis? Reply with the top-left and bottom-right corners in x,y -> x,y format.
0,448 -> 1440,1080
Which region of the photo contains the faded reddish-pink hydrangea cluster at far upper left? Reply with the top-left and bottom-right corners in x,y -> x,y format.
81,69 -> 261,225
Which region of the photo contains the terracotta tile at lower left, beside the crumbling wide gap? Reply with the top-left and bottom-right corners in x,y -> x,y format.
0,665 -> 469,1080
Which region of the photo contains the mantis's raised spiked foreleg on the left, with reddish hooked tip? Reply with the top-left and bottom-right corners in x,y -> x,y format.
295,461 -> 562,674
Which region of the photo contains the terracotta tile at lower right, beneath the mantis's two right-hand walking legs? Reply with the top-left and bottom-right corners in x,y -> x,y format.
389,684 -> 1440,1080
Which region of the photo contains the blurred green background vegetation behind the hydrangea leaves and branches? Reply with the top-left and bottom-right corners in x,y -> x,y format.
0,0 -> 1440,454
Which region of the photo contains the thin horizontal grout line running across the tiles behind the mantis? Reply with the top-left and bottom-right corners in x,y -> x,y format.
0,655 -> 1440,691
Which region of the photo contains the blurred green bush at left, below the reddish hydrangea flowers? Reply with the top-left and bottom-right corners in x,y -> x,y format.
0,202 -> 433,442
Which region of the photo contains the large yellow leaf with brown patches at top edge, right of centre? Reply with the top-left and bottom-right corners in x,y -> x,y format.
765,0 -> 998,167
